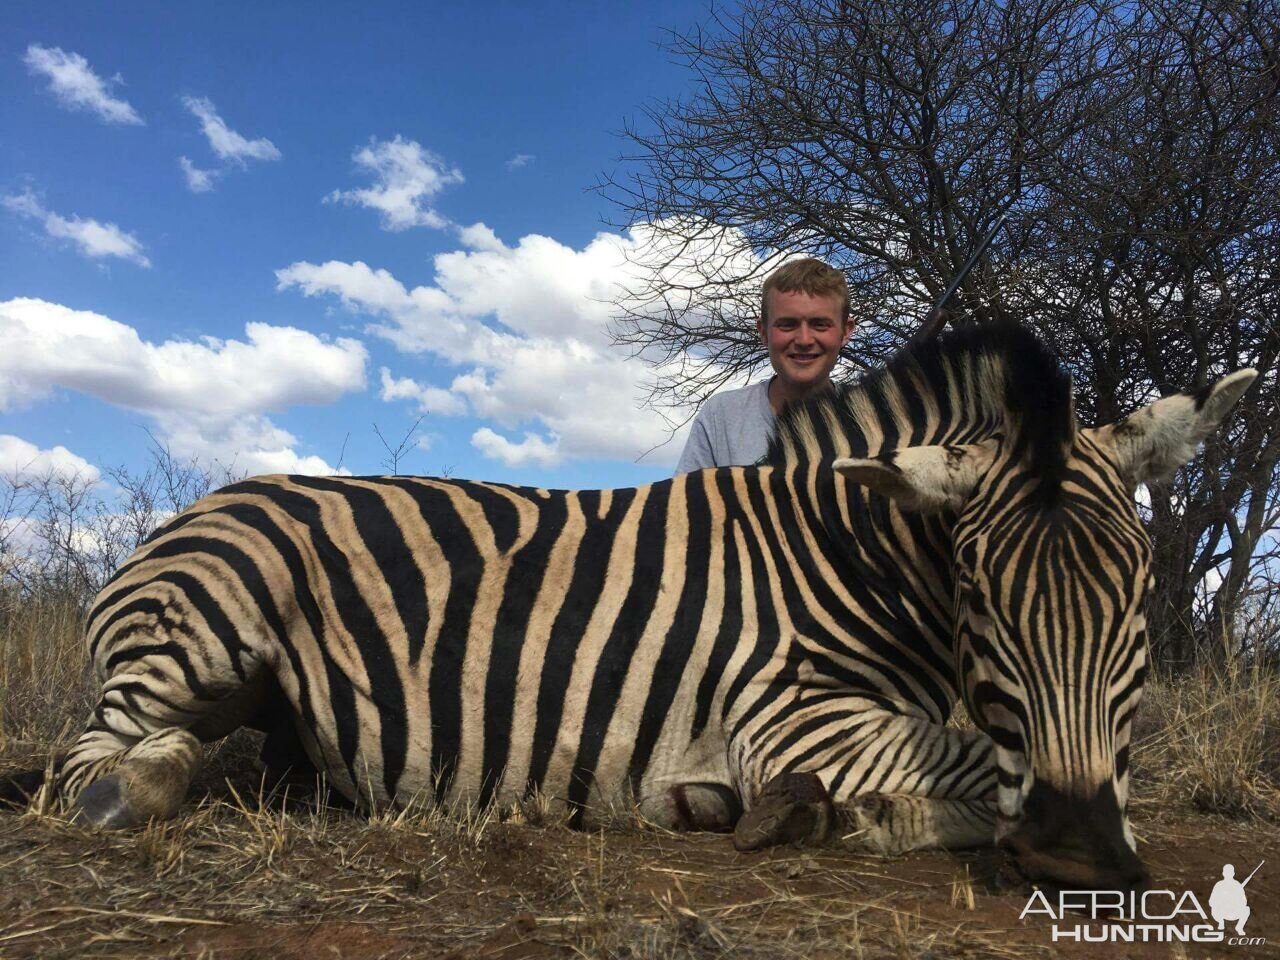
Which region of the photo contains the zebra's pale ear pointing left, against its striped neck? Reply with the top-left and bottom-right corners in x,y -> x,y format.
831,439 -> 998,513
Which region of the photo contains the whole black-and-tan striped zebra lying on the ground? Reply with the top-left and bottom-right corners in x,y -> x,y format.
15,323 -> 1256,888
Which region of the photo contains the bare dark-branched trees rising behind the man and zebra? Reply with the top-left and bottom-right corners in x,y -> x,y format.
603,0 -> 1280,667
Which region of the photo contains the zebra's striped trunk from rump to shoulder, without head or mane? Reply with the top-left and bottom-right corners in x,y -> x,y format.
65,467 -> 989,826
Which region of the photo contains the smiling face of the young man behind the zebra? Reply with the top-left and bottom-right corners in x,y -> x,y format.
756,291 -> 854,392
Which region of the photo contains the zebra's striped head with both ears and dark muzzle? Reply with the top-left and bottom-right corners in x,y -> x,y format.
835,370 -> 1256,890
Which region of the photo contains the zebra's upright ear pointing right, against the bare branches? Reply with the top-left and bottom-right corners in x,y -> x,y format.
1088,369 -> 1258,486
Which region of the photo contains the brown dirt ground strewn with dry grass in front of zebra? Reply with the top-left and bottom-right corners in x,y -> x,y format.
0,747 -> 1280,960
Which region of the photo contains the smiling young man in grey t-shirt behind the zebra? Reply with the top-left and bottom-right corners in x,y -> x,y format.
676,259 -> 854,474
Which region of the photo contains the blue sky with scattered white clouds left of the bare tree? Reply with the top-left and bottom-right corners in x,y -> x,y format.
0,0 -> 747,496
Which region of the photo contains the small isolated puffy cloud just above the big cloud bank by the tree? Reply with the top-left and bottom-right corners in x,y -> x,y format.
325,134 -> 462,230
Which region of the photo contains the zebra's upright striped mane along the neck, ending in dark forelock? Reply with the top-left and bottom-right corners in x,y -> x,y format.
762,321 -> 1075,498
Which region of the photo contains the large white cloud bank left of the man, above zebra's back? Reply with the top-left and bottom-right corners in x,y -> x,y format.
276,224 -> 768,466
